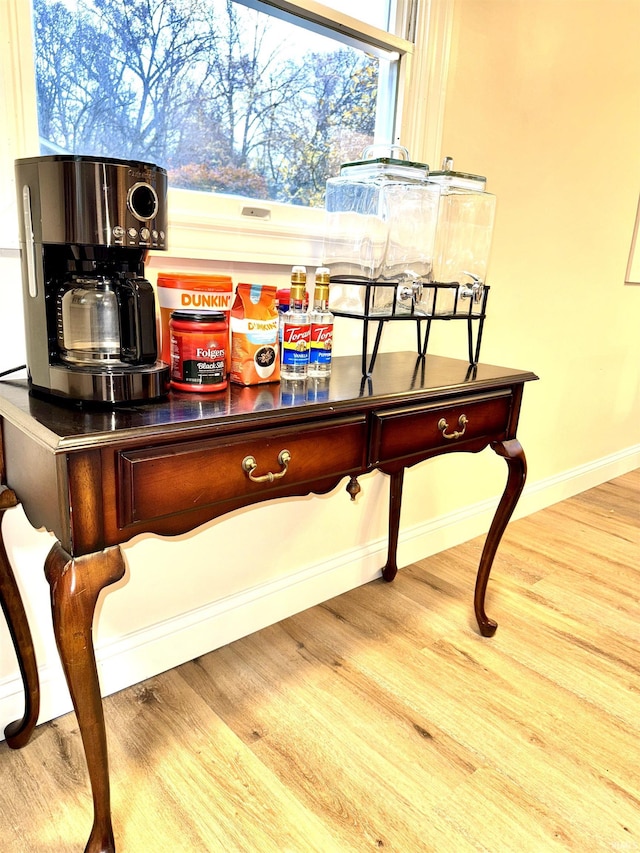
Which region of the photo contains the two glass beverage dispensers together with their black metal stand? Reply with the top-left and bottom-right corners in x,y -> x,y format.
324,146 -> 496,376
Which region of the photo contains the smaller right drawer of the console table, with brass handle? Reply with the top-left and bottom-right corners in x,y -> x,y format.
369,390 -> 512,466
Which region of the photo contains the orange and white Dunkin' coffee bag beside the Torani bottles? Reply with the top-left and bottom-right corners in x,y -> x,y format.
230,284 -> 280,385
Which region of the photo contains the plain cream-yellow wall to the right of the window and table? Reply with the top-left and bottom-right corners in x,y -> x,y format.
443,0 -> 640,480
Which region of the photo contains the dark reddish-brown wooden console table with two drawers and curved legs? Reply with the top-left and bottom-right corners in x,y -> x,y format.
0,353 -> 537,853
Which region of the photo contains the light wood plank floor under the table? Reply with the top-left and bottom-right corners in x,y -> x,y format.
0,470 -> 640,853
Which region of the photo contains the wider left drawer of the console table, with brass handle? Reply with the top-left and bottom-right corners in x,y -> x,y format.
116,415 -> 367,527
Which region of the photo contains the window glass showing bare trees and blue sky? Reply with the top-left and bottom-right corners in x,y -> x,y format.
33,0 -> 412,207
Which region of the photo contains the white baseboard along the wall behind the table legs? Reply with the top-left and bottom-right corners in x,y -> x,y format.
0,445 -> 640,727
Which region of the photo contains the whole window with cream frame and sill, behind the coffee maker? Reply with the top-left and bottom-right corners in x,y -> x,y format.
0,0 -> 452,260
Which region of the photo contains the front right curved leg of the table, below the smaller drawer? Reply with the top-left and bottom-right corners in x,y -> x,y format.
473,438 -> 527,637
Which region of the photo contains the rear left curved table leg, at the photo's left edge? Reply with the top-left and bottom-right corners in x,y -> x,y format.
0,486 -> 40,749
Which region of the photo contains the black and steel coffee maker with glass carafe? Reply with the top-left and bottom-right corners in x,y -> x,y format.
16,155 -> 170,405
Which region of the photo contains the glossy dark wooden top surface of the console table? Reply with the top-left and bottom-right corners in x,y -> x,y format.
0,352 -> 537,452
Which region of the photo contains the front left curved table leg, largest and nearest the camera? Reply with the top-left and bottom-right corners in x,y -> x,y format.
45,542 -> 125,853
